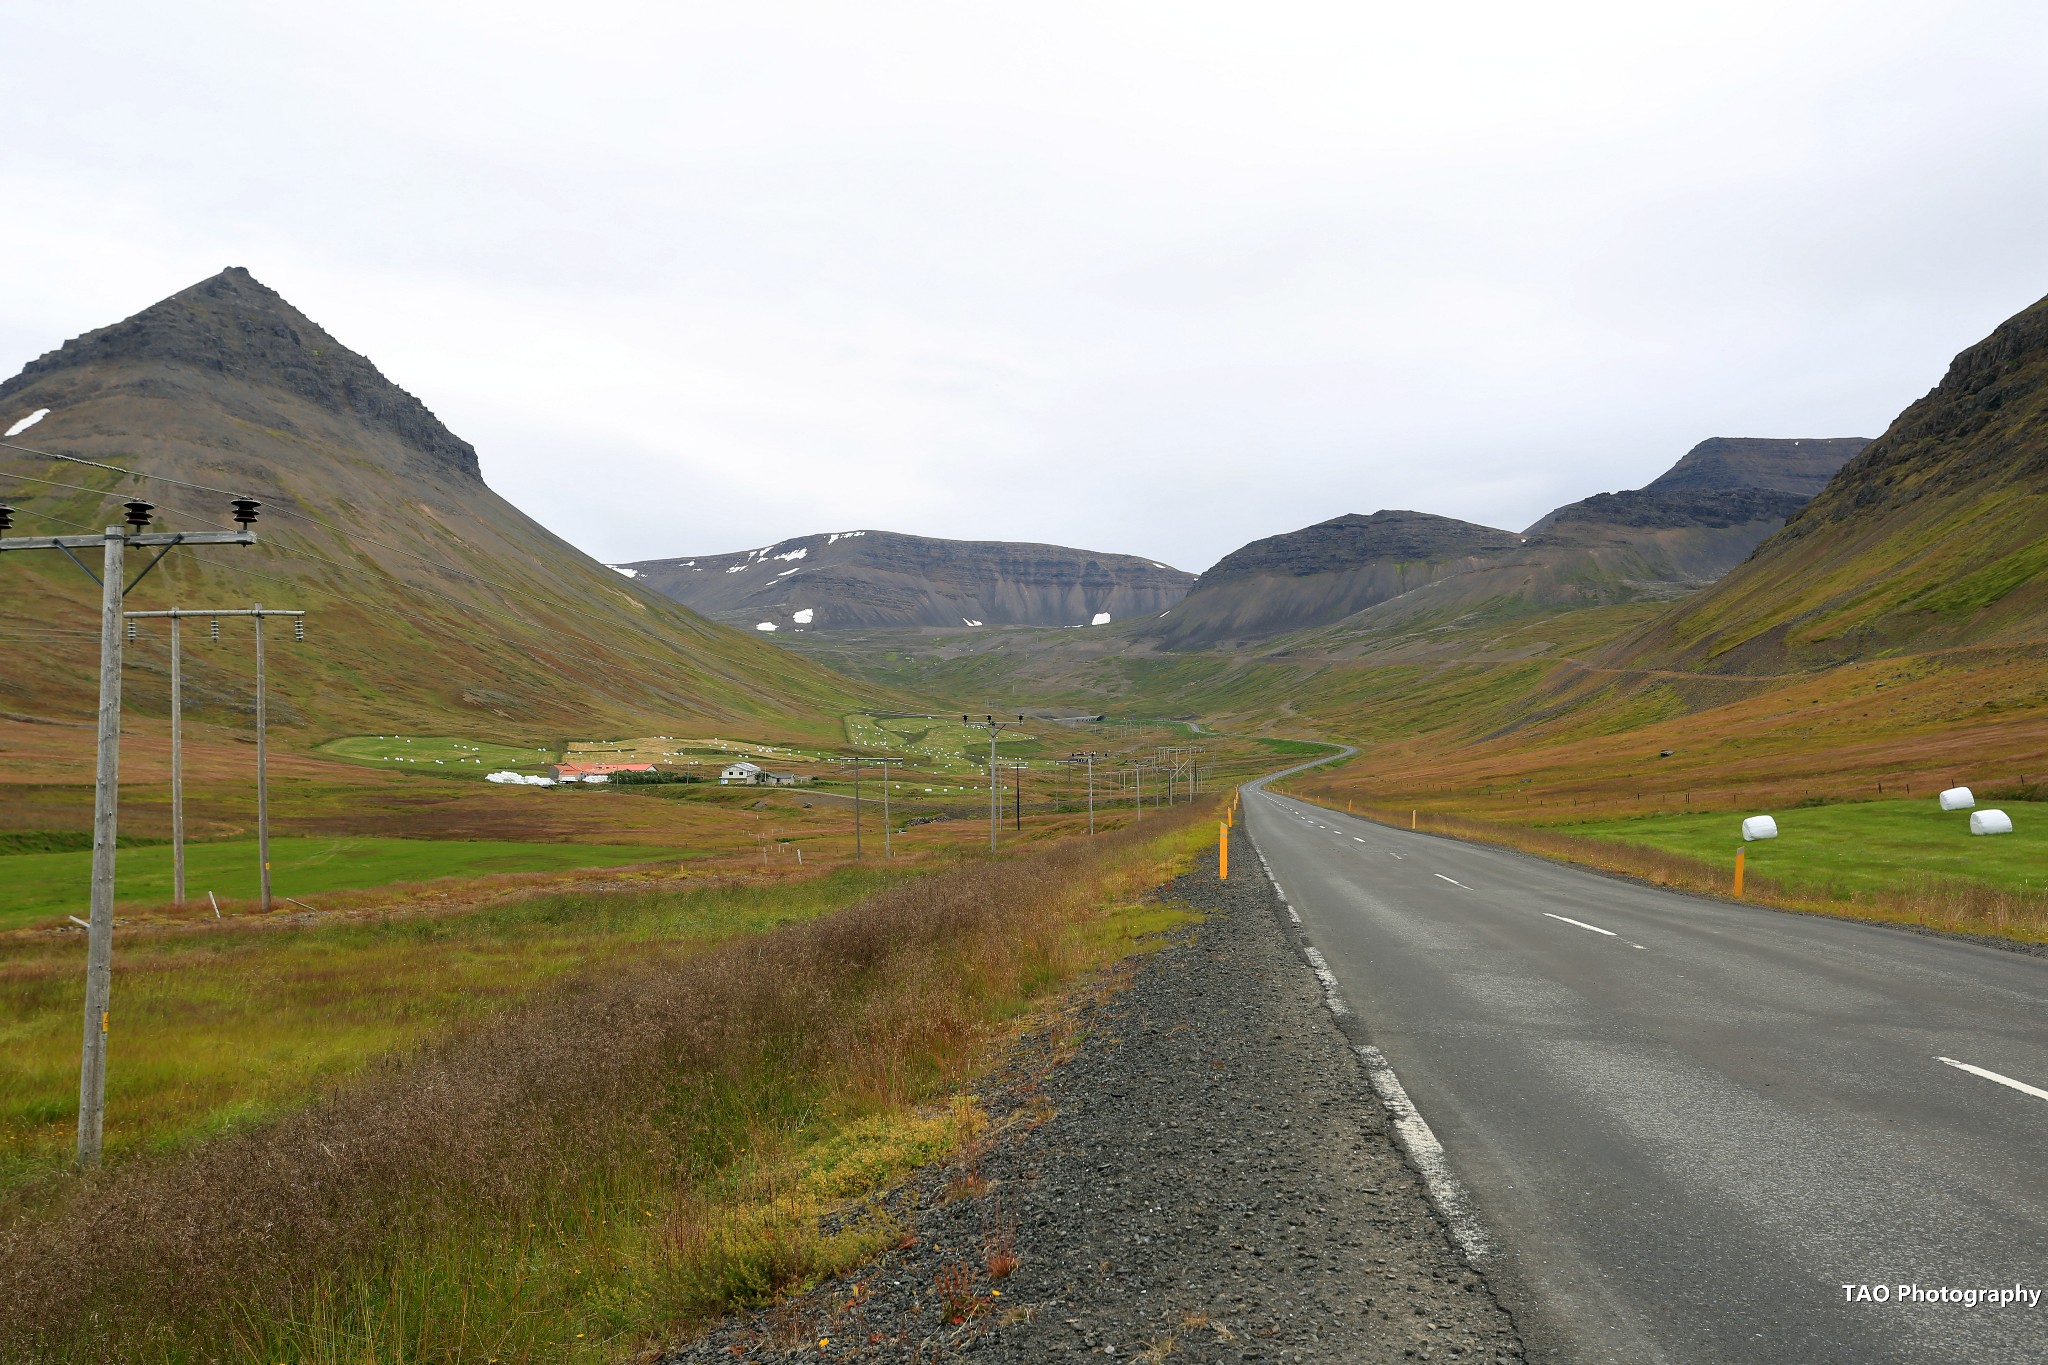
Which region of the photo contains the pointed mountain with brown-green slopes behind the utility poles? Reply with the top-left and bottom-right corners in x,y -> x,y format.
0,270 -> 897,741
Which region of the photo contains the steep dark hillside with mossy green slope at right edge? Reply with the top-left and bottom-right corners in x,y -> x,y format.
1610,299 -> 2048,673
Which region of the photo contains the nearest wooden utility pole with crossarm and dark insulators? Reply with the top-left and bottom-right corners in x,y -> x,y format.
0,497 -> 262,1166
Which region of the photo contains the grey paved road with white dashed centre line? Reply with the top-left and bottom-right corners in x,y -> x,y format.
1243,786 -> 2048,1365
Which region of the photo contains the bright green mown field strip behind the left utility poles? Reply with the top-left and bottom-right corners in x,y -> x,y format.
0,837 -> 680,929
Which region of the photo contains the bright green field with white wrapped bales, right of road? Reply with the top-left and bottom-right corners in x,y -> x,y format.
1552,800 -> 2048,894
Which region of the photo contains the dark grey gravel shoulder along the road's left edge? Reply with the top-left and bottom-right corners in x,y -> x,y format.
664,833 -> 1522,1365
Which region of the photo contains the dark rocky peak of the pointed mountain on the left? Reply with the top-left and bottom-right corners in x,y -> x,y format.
0,266 -> 481,479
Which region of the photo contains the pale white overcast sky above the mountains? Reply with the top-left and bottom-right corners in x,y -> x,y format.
0,0 -> 2048,569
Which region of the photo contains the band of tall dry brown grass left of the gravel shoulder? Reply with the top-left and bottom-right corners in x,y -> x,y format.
0,806 -> 1208,1361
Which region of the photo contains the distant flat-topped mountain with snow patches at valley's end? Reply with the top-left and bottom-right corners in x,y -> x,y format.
614,530 -> 1194,632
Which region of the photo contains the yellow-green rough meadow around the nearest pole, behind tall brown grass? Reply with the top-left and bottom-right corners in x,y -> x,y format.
0,860 -> 901,1189
